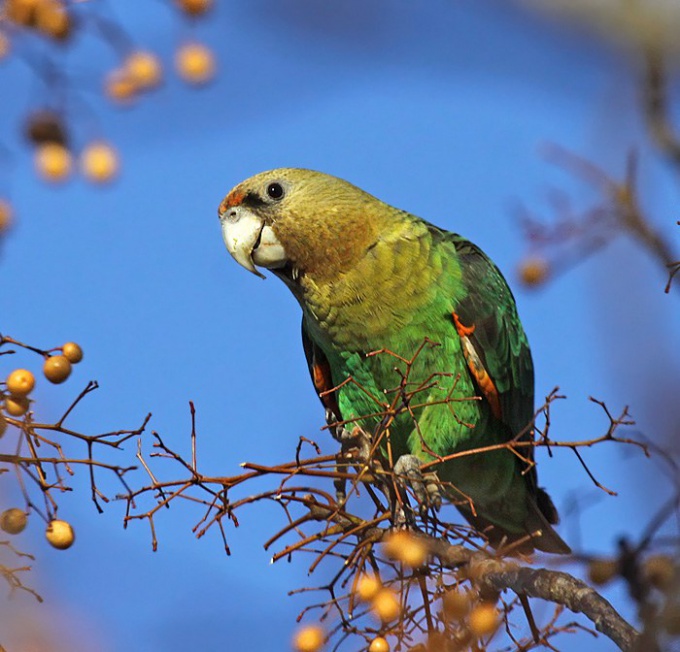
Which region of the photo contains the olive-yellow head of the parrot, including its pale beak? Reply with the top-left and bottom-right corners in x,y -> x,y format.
218,168 -> 385,284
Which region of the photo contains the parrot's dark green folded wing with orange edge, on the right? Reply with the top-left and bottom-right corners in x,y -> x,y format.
429,226 -> 558,524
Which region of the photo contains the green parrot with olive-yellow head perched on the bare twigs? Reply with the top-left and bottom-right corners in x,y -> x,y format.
219,168 -> 570,554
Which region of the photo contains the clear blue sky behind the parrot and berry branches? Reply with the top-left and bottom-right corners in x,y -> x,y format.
0,0 -> 680,652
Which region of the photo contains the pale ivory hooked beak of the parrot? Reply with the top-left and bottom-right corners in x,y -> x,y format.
220,206 -> 288,278
